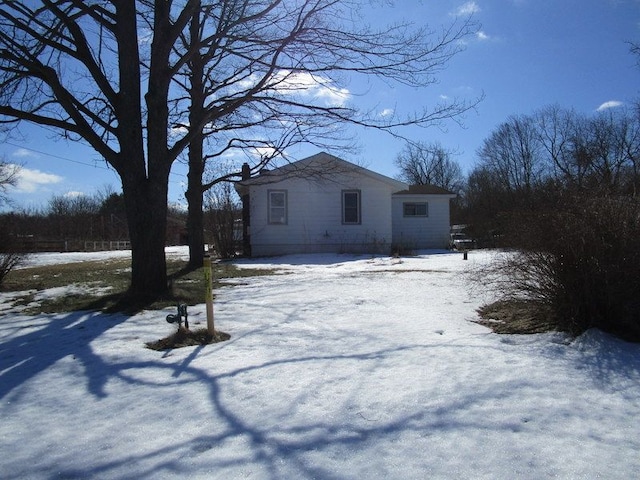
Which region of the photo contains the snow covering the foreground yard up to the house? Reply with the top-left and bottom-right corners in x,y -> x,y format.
0,252 -> 640,480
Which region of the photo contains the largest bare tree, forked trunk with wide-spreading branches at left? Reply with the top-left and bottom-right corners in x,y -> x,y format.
0,0 -> 475,297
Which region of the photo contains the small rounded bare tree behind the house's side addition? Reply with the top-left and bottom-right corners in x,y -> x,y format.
395,142 -> 464,193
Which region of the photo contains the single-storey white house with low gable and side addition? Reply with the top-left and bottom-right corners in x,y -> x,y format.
236,152 -> 455,256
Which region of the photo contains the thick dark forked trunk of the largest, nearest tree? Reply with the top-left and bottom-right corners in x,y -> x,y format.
109,2 -> 171,301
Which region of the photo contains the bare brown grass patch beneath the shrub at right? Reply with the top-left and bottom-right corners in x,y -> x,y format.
476,299 -> 557,334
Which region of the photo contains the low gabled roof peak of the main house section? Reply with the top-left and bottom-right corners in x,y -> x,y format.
239,152 -> 407,189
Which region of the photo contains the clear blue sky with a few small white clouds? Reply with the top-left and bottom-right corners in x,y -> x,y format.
0,0 -> 640,207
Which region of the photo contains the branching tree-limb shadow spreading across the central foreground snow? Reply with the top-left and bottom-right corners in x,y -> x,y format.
46,345 -> 540,480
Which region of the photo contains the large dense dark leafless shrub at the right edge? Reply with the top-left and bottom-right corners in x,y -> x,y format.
482,196 -> 640,341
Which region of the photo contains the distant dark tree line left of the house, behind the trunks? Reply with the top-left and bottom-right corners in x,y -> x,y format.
0,182 -> 242,258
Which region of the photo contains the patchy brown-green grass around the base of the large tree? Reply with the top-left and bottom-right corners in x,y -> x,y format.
2,259 -> 274,315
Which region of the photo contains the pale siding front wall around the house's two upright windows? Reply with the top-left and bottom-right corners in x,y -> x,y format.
250,174 -> 397,256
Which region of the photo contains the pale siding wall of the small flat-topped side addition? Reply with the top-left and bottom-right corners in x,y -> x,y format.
392,194 -> 450,250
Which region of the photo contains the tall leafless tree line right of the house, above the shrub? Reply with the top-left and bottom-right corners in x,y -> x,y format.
464,106 -> 640,241
